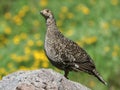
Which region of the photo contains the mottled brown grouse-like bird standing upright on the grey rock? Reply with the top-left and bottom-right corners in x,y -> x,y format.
40,9 -> 107,85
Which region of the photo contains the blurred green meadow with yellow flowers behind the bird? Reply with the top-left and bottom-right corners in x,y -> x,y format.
0,0 -> 120,90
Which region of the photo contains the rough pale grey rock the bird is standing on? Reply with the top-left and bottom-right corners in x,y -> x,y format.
0,69 -> 90,90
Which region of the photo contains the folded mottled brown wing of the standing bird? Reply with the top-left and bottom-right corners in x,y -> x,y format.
55,37 -> 95,74
